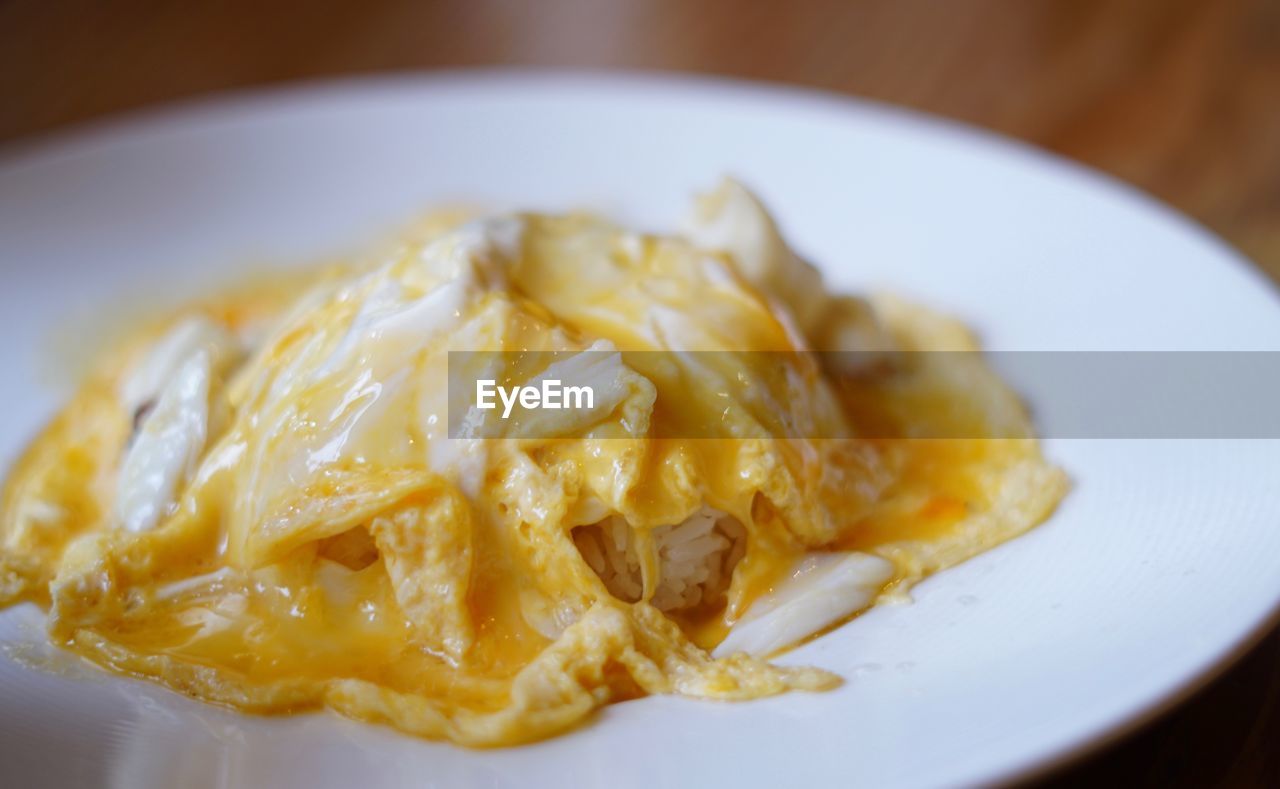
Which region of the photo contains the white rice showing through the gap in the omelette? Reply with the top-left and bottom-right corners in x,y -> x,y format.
573,506 -> 746,611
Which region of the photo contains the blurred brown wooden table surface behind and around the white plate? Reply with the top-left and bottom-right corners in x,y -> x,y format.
0,0 -> 1280,786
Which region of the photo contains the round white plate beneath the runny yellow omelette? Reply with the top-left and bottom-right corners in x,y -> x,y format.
0,73 -> 1280,789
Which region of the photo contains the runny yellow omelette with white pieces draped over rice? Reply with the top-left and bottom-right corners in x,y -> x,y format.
0,181 -> 1068,747
